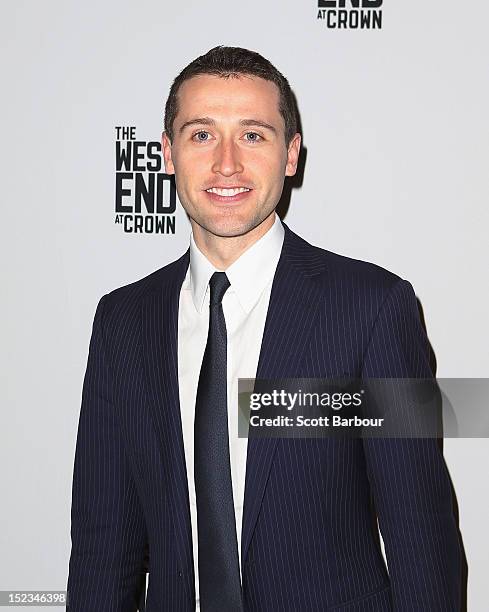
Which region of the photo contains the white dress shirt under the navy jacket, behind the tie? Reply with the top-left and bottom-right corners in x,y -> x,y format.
178,215 -> 284,610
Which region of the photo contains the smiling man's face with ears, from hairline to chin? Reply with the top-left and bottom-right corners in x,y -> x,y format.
162,75 -> 300,237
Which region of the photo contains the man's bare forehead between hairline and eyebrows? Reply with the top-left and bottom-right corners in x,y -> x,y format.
176,74 -> 282,127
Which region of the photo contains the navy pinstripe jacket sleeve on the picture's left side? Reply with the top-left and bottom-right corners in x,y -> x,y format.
68,296 -> 146,612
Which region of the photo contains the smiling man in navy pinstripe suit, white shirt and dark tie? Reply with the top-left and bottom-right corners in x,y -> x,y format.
68,47 -> 460,612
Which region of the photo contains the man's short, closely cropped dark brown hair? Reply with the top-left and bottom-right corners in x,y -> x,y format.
165,46 -> 297,145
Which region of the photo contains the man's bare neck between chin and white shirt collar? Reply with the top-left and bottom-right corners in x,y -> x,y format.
191,211 -> 275,271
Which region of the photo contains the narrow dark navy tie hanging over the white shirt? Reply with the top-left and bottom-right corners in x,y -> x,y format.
194,272 -> 243,612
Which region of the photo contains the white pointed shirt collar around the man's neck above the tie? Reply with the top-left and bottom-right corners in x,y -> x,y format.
189,214 -> 285,313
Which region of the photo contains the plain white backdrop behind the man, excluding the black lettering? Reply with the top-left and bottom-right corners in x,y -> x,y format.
0,0 -> 489,612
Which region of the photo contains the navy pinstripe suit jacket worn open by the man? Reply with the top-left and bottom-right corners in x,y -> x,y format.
68,227 -> 460,612
